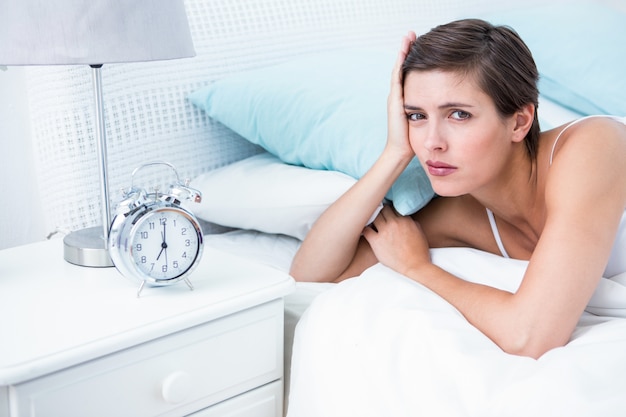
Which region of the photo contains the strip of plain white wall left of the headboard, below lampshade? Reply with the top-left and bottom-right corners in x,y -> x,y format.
0,67 -> 47,249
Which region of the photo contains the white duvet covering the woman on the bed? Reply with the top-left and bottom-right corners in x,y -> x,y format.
288,249 -> 626,417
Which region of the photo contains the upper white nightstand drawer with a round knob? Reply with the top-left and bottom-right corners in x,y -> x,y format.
11,300 -> 283,417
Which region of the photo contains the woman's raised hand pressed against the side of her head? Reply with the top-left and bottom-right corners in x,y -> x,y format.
385,32 -> 416,160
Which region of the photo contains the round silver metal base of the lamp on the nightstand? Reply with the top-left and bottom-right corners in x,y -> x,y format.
63,226 -> 113,268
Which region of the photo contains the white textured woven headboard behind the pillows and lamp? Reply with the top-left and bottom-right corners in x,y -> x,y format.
27,0 -> 556,237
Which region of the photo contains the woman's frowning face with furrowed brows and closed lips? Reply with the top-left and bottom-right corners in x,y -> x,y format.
404,71 -> 514,196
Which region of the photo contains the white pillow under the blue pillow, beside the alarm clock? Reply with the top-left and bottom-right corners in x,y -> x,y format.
191,153 -> 356,240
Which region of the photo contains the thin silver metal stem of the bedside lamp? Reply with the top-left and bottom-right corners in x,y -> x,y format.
91,64 -> 111,240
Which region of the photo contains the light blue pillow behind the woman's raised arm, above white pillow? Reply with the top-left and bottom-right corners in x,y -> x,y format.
189,49 -> 434,214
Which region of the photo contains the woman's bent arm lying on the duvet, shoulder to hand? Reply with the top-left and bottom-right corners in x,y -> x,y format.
364,120 -> 626,358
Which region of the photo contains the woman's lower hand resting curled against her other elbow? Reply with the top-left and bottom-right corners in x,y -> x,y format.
363,206 -> 431,275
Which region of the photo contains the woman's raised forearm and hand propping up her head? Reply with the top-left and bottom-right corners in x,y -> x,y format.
290,33 -> 415,281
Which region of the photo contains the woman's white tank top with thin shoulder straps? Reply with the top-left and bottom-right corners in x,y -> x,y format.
487,116 -> 626,278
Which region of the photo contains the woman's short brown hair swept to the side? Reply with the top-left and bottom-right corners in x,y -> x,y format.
402,19 -> 540,161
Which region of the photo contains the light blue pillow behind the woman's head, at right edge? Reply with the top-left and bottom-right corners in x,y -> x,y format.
482,2 -> 626,115
